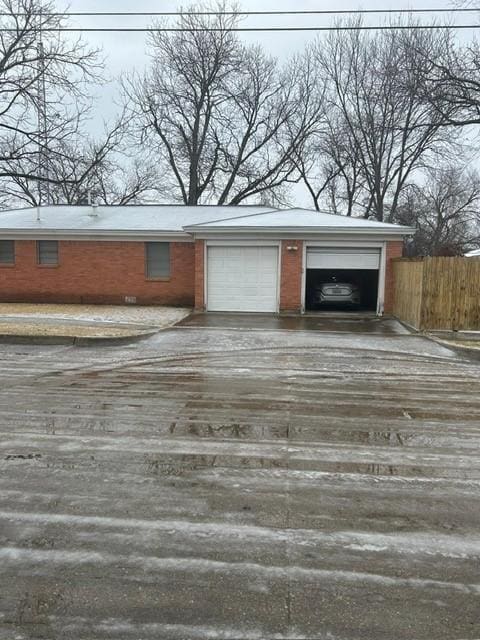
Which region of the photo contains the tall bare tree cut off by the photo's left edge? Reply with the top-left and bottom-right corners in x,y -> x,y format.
0,0 -> 100,201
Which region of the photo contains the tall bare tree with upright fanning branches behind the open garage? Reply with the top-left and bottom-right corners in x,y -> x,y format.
314,25 -> 458,220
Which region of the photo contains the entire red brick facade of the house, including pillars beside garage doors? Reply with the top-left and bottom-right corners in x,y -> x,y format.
0,240 -> 403,314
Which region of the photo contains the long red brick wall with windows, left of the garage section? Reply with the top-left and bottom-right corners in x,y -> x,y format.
0,240 -> 195,306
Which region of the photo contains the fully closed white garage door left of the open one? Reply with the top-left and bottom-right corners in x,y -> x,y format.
207,246 -> 278,312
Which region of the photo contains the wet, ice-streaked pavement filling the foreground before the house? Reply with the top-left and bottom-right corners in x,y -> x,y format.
0,321 -> 480,640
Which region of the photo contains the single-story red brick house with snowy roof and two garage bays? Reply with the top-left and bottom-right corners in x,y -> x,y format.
0,205 -> 413,314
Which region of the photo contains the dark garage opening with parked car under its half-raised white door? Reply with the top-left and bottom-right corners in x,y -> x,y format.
305,247 -> 380,313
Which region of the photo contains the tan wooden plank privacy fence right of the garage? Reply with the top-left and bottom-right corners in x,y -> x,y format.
393,258 -> 480,331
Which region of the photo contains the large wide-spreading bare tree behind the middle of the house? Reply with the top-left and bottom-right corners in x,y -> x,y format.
125,4 -> 319,205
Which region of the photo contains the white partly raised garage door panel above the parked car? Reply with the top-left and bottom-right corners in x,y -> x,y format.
307,247 -> 380,269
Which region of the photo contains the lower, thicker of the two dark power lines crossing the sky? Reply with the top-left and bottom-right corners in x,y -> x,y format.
0,24 -> 480,33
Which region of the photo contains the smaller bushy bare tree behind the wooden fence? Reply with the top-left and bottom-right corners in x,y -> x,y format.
395,165 -> 480,256
